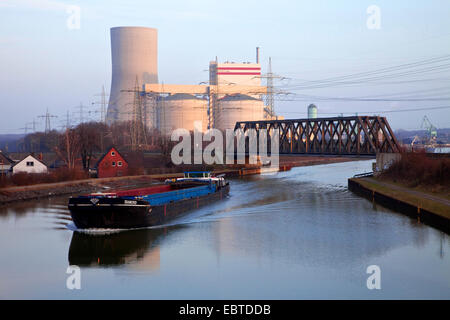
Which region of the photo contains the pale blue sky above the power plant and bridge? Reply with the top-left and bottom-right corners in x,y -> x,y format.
0,0 -> 450,134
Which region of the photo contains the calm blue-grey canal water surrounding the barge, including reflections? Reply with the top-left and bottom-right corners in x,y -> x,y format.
0,161 -> 450,299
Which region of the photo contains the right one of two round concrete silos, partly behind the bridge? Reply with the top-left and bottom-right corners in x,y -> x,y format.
214,94 -> 264,130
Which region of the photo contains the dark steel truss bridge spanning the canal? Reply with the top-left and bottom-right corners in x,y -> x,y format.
235,116 -> 400,156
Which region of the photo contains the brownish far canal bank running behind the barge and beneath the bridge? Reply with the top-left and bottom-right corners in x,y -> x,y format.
0,155 -> 361,205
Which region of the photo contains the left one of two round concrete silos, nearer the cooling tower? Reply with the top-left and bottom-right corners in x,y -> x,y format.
158,93 -> 208,136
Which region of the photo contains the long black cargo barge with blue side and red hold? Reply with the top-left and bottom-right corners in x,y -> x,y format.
68,172 -> 230,229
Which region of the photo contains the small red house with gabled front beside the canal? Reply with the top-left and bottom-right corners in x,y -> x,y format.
95,147 -> 128,178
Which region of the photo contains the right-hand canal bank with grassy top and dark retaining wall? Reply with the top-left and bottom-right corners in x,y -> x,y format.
348,177 -> 450,233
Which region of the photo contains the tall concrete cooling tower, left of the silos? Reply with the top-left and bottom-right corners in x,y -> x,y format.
106,27 -> 158,124
